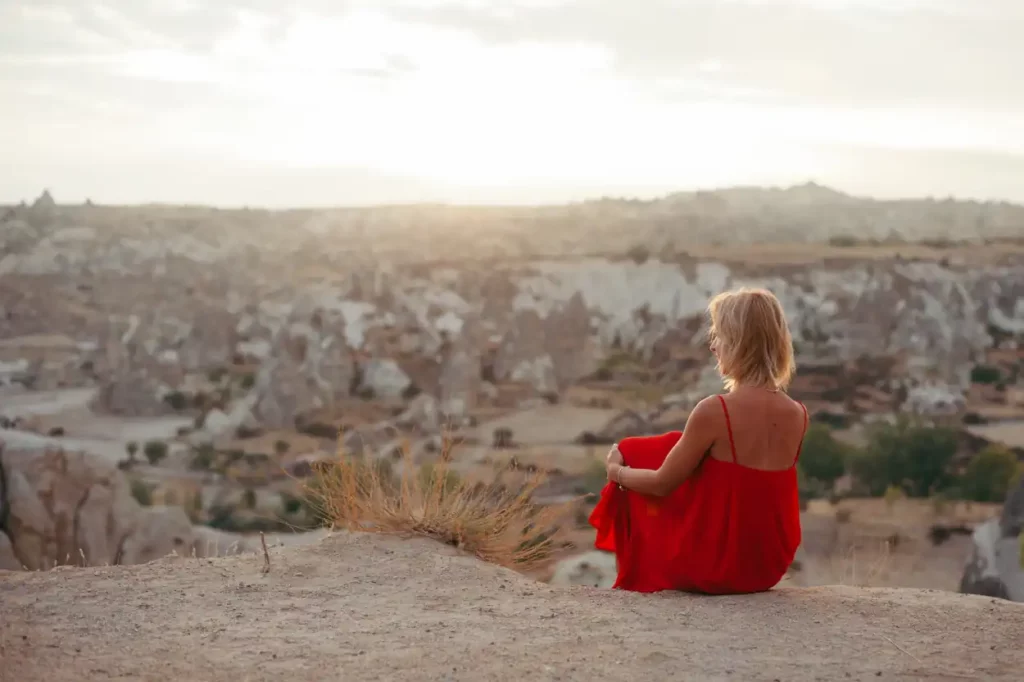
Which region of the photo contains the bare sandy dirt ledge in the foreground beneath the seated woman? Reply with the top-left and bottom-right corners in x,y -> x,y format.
0,535 -> 1024,682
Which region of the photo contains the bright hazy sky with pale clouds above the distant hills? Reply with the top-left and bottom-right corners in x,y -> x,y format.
0,0 -> 1024,207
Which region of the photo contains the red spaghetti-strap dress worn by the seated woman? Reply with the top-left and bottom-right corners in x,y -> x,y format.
590,396 -> 807,594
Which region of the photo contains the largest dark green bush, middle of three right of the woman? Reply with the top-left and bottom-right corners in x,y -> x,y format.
850,419 -> 957,498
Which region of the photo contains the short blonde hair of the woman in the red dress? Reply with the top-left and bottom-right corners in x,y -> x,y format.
708,288 -> 797,391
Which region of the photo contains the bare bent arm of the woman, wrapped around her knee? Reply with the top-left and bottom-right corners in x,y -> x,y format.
608,397 -> 721,498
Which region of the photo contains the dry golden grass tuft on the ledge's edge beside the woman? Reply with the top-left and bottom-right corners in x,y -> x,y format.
305,430 -> 580,570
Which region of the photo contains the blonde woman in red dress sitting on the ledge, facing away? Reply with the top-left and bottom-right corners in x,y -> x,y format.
591,289 -> 807,594
